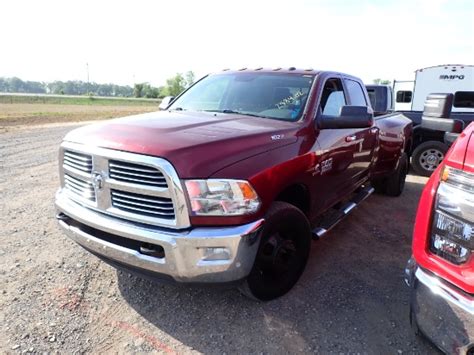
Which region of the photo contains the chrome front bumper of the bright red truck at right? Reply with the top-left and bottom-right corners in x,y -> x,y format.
405,259 -> 474,354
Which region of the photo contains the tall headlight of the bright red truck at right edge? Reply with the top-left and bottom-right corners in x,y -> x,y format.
430,167 -> 474,264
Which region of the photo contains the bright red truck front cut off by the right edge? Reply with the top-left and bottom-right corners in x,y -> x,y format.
406,123 -> 474,354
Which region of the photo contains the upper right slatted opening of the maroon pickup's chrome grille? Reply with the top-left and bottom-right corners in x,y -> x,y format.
109,160 -> 168,188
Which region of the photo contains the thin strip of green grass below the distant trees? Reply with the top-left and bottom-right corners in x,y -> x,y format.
0,94 -> 161,107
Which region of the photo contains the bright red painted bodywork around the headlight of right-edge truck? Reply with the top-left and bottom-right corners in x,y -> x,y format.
413,123 -> 474,294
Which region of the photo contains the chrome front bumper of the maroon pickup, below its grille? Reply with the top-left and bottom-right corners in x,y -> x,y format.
56,191 -> 263,283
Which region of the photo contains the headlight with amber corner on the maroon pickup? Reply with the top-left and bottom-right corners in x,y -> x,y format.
185,179 -> 260,216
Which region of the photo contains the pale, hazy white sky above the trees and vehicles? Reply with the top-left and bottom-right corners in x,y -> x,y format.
0,0 -> 474,85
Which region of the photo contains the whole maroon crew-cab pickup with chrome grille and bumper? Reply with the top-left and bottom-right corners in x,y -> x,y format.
56,68 -> 412,300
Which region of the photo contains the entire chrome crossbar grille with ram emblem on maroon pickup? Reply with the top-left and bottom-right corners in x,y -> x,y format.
60,142 -> 191,229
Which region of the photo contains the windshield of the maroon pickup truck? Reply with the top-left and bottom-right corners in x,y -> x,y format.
169,73 -> 314,121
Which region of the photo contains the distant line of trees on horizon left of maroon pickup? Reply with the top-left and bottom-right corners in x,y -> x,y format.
0,71 -> 195,98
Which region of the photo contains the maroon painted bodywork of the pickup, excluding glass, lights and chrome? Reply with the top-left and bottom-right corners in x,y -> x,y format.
65,70 -> 412,226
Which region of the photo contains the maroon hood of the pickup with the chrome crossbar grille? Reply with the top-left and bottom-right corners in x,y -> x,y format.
64,111 -> 299,178
